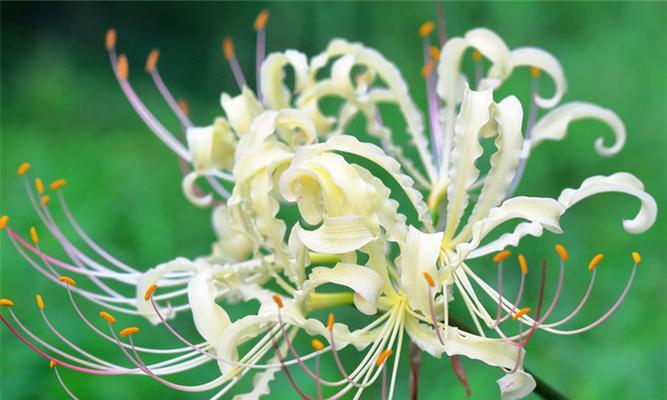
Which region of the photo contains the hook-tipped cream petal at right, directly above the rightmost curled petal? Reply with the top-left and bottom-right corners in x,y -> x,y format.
532,101 -> 626,156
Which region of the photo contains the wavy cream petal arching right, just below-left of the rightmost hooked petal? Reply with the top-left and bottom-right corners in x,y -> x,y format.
449,197 -> 566,260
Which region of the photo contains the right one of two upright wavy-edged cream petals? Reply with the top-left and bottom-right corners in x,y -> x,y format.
459,96 -> 523,240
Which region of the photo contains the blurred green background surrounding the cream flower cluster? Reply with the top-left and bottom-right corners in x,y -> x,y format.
0,2 -> 667,400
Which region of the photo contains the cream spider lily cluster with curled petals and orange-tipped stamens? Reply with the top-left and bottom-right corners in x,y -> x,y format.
0,7 -> 657,399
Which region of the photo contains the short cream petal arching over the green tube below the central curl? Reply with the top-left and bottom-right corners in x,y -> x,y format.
303,263 -> 384,315
